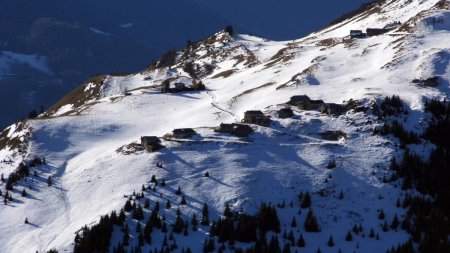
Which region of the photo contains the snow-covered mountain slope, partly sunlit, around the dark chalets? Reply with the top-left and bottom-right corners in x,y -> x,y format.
0,0 -> 450,252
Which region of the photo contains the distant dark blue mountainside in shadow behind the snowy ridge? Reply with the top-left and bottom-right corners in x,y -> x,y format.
0,0 -> 365,128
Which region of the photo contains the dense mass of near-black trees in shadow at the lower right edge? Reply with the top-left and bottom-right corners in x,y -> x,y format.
388,100 -> 450,253
